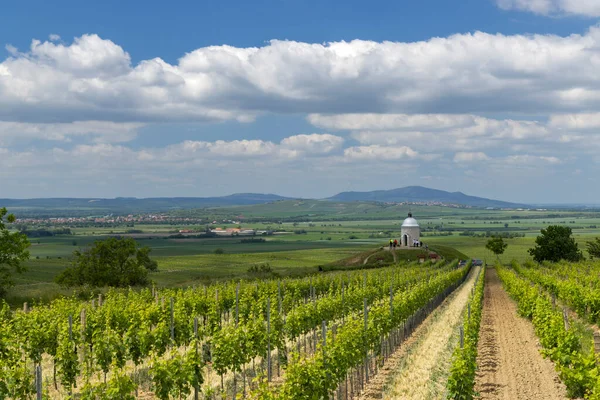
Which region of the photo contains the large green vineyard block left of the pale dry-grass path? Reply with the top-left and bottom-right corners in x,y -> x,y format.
0,262 -> 469,399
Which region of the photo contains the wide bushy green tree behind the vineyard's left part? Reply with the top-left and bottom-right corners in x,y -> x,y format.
55,237 -> 157,287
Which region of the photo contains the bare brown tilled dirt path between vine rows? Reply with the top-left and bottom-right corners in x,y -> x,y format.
475,268 -> 566,400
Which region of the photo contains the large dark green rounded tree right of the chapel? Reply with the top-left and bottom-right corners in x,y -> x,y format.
528,225 -> 583,262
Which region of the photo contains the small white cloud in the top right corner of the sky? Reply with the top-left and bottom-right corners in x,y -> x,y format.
496,0 -> 600,17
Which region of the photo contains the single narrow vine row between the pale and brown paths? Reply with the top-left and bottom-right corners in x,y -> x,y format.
447,268 -> 485,400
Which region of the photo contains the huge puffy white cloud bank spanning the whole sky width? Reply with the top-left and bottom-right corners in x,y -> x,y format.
5,27 -> 600,128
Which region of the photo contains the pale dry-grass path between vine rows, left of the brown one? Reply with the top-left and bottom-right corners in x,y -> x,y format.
361,268 -> 479,400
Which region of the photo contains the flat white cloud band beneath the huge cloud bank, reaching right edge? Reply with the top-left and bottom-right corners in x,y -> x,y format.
308,113 -> 600,155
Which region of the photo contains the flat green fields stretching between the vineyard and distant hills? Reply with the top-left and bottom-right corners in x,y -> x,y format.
8,205 -> 600,303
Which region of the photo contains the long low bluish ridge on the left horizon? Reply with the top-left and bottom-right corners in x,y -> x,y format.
0,193 -> 289,215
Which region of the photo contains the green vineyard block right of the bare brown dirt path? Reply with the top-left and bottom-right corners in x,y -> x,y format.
497,262 -> 600,399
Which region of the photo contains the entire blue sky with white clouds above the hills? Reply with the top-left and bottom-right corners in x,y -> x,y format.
0,0 -> 600,204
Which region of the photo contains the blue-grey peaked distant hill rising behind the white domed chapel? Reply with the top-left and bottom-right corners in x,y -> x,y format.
327,186 -> 527,208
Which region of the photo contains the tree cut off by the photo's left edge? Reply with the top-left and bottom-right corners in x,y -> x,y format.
0,208 -> 30,297
